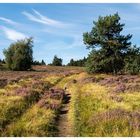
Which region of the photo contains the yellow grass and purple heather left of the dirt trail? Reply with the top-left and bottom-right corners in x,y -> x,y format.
0,67 -> 82,136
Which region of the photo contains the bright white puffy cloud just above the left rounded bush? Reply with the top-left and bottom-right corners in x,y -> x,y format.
2,26 -> 27,41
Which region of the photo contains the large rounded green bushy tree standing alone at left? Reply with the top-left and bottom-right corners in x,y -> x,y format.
3,38 -> 33,70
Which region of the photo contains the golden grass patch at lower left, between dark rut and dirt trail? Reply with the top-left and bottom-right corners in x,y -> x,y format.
3,105 -> 55,137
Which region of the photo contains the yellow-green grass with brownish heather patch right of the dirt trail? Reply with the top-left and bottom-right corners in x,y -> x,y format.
66,74 -> 140,136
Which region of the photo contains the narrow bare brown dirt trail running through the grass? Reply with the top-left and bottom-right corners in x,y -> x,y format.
58,89 -> 73,137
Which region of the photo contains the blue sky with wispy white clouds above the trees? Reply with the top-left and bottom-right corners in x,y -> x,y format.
0,3 -> 140,64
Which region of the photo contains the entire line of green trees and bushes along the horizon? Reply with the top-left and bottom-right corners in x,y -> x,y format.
1,13 -> 140,74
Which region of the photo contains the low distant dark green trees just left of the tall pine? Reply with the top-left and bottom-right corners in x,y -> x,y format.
67,57 -> 87,67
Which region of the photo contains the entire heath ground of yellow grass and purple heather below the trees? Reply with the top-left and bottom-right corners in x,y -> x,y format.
0,66 -> 140,136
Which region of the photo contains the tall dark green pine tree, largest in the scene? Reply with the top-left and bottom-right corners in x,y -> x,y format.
83,13 -> 136,74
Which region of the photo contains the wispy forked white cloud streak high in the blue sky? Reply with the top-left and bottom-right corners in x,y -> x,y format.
22,9 -> 69,27
